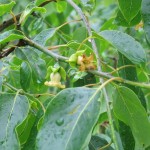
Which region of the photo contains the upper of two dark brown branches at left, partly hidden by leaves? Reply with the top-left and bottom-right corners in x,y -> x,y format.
0,0 -> 56,32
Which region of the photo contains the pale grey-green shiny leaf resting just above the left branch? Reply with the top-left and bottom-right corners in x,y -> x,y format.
33,28 -> 56,46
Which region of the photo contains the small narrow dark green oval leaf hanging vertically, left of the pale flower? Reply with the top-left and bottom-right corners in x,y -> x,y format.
20,62 -> 32,91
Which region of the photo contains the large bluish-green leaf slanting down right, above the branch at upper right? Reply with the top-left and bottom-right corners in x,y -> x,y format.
94,30 -> 146,65
